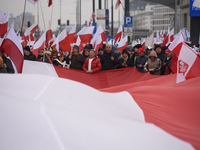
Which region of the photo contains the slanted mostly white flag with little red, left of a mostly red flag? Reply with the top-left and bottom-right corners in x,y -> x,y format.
52,29 -> 67,52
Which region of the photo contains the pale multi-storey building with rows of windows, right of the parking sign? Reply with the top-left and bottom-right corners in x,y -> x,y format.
152,5 -> 175,31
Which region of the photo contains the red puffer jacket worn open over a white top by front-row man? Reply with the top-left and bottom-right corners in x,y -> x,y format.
82,58 -> 101,73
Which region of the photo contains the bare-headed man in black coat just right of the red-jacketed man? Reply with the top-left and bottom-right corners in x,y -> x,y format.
101,44 -> 118,70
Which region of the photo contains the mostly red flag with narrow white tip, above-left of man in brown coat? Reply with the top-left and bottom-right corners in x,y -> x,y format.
60,24 -> 76,52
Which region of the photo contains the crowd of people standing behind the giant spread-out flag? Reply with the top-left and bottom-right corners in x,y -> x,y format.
0,41 -> 199,75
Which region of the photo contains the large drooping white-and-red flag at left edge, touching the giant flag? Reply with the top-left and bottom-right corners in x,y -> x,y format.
1,27 -> 24,73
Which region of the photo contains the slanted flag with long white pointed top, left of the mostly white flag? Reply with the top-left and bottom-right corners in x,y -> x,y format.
31,31 -> 46,56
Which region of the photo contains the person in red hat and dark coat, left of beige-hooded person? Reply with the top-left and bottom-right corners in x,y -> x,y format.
134,48 -> 149,72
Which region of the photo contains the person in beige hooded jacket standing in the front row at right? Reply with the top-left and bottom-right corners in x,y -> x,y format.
144,51 -> 161,75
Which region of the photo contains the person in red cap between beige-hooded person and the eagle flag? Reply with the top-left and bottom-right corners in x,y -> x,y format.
163,49 -> 173,75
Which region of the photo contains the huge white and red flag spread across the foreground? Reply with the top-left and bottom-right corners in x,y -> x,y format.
3,61 -> 200,150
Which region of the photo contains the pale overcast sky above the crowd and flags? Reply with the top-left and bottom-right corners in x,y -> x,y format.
0,0 -> 124,30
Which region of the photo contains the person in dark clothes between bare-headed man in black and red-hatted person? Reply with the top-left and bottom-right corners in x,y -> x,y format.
117,49 -> 133,68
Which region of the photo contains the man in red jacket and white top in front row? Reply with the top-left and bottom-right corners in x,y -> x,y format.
82,49 -> 101,73
